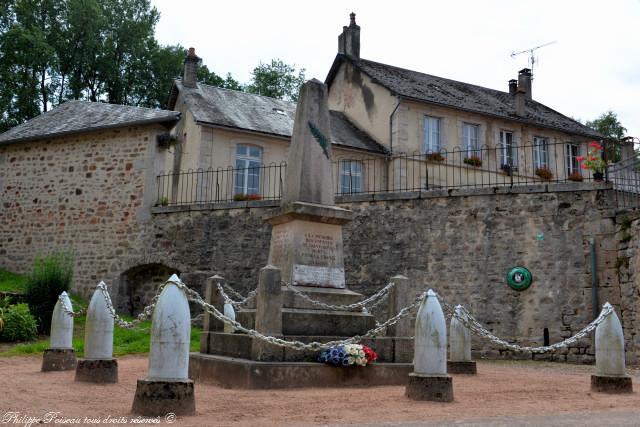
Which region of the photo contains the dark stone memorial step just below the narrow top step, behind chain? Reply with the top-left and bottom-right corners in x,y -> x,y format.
236,308 -> 375,337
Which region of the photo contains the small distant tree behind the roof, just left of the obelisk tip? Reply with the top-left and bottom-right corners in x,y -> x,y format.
246,59 -> 305,101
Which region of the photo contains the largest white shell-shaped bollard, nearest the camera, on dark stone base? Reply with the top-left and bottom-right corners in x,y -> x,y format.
132,274 -> 195,416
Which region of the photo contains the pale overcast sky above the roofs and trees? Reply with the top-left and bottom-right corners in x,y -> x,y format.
152,0 -> 640,137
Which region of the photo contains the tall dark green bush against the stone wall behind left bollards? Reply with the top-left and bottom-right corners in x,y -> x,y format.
24,253 -> 73,334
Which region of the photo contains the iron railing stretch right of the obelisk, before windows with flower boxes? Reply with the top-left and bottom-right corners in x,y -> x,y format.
334,143 -> 600,195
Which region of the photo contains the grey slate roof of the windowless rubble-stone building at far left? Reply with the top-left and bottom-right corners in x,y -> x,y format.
0,101 -> 180,145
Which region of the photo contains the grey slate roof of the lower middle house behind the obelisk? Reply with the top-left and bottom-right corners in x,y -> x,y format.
169,80 -> 387,153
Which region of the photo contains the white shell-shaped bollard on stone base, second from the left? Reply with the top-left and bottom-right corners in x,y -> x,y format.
76,282 -> 118,383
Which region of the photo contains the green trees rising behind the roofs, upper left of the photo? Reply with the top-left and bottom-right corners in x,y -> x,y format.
0,0 -> 304,132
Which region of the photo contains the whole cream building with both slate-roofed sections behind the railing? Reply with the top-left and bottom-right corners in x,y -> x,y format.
160,14 -> 602,204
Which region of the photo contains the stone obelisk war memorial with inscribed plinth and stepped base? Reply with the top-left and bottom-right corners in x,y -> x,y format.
189,79 -> 412,388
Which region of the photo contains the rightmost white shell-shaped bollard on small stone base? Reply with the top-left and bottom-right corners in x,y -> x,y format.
591,303 -> 633,393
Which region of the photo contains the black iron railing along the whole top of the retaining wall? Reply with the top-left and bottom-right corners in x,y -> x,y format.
157,142 -> 640,206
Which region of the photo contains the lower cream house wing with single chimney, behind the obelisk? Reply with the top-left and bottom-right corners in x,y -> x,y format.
159,48 -> 387,203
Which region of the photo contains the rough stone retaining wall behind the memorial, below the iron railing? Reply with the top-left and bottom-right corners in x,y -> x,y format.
145,184 -> 620,362
